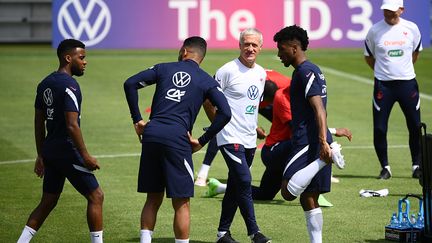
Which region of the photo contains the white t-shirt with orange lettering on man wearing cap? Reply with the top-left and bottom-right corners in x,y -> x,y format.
364,18 -> 423,81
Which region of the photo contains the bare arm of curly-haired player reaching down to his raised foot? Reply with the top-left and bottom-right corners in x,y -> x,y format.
309,95 -> 332,164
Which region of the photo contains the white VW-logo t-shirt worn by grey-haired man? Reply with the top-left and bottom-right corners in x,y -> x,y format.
215,59 -> 266,148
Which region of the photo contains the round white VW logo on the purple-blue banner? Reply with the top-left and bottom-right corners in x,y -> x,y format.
57,0 -> 111,46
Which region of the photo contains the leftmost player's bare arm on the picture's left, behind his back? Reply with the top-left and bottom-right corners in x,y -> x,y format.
34,109 -> 46,178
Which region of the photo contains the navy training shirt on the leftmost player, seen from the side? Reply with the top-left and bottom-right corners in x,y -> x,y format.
35,72 -> 82,158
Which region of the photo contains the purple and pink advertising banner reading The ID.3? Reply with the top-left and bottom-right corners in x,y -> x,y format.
52,0 -> 431,49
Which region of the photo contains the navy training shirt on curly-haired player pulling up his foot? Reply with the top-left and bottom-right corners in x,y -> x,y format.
290,61 -> 332,145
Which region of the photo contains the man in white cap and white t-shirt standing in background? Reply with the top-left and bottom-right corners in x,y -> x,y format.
364,0 -> 423,180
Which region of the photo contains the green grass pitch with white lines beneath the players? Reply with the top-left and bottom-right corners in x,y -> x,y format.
0,45 -> 432,243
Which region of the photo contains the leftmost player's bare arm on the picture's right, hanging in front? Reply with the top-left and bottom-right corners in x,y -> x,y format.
65,112 -> 100,170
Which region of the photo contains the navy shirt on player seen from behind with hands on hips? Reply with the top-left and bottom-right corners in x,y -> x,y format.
124,60 -> 231,150
